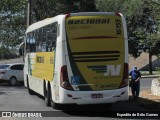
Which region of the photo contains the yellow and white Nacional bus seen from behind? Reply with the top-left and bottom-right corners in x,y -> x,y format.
24,12 -> 129,108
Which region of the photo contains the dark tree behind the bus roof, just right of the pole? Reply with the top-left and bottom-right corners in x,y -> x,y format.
31,0 -> 96,22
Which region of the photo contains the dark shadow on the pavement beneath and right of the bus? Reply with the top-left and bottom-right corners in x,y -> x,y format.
62,96 -> 160,119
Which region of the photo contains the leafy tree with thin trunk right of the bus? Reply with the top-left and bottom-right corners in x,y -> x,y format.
128,0 -> 160,74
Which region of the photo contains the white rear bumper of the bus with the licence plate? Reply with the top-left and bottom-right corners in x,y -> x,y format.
59,87 -> 129,105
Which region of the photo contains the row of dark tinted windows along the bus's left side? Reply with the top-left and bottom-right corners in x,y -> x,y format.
26,22 -> 60,52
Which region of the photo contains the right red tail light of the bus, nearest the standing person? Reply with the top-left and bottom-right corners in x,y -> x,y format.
119,63 -> 128,88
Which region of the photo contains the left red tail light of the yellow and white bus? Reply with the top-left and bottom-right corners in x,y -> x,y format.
60,65 -> 73,90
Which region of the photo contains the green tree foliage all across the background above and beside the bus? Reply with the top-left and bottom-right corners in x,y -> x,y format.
0,0 -> 160,57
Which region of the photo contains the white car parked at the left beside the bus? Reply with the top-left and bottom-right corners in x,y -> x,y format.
0,63 -> 24,86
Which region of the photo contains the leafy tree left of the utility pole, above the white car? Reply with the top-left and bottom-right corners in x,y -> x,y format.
0,0 -> 26,46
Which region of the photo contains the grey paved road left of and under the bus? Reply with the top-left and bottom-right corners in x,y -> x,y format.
0,84 -> 159,120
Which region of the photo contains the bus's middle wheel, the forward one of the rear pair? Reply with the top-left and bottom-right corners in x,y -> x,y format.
44,83 -> 51,106
